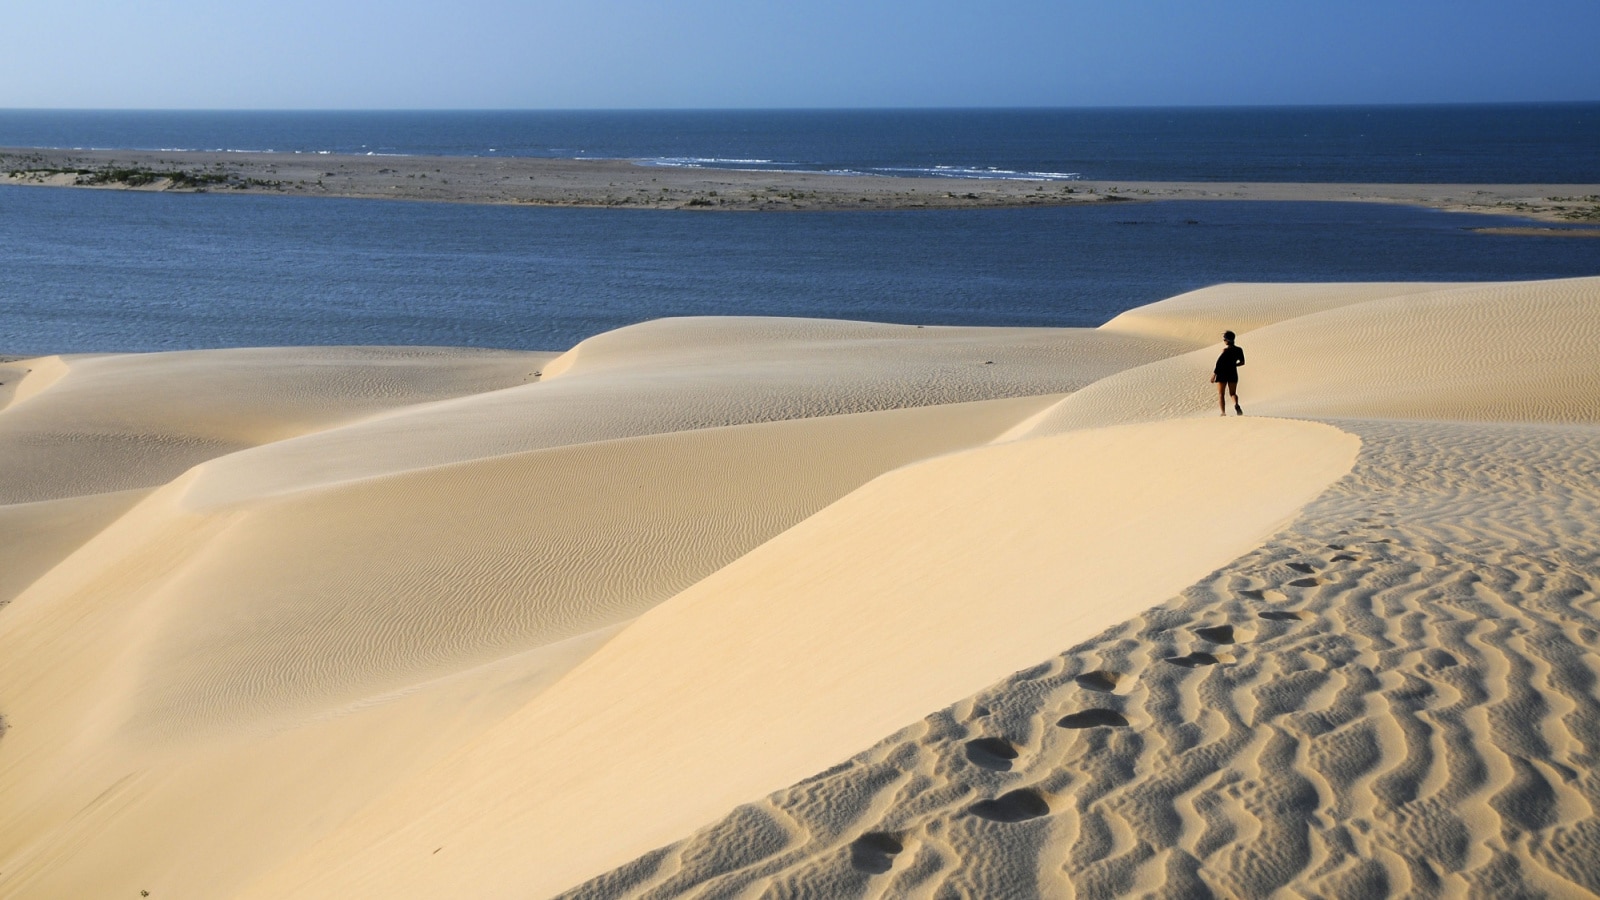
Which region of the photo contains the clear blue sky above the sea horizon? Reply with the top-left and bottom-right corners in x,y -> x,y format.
0,0 -> 1600,109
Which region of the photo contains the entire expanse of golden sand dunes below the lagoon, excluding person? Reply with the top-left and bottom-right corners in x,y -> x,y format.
0,279 -> 1600,898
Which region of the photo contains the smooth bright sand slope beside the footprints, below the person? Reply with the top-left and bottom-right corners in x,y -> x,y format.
236,420 -> 1355,897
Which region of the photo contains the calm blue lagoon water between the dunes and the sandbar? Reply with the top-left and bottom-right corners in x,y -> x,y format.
0,186 -> 1600,354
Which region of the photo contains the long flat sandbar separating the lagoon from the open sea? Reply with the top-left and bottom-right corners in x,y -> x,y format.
0,147 -> 1600,224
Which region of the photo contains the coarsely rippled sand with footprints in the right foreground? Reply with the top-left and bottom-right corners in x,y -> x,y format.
563,421 -> 1600,898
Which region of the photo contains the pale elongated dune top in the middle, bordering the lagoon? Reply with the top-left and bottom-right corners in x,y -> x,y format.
187,317 -> 1186,495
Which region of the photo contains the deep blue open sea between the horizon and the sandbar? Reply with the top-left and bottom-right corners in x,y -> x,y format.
0,102 -> 1600,184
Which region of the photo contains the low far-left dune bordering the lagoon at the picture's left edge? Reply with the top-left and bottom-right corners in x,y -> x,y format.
0,348 -> 549,503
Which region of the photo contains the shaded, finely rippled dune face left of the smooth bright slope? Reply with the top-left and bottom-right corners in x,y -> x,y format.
141,399 -> 1043,727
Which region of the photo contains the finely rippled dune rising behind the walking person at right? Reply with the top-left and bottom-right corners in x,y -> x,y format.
1035,277 -> 1600,434
